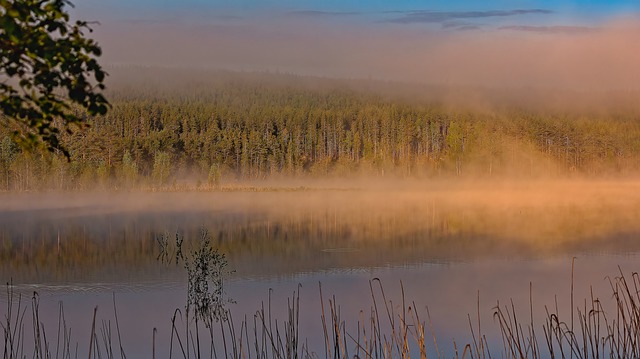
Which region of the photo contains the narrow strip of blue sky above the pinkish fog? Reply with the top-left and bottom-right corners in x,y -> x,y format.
81,0 -> 640,23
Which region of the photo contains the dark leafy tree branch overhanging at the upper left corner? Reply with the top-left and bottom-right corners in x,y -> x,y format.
0,0 -> 109,158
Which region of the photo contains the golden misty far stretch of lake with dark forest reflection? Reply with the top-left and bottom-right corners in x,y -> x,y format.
0,181 -> 640,283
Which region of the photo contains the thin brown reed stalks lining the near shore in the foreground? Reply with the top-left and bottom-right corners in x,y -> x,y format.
1,262 -> 640,359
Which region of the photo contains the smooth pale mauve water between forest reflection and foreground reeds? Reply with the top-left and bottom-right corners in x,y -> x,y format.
2,254 -> 638,358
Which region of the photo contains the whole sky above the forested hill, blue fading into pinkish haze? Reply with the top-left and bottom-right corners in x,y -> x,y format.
72,0 -> 640,90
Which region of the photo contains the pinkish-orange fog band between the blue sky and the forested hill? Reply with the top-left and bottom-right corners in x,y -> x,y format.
95,13 -> 640,91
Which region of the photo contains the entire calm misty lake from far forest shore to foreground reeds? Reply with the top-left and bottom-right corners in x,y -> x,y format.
0,180 -> 640,358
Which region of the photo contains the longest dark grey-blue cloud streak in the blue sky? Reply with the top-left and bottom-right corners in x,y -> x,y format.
386,9 -> 553,24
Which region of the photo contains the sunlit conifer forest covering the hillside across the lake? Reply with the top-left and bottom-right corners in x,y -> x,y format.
0,75 -> 640,191
